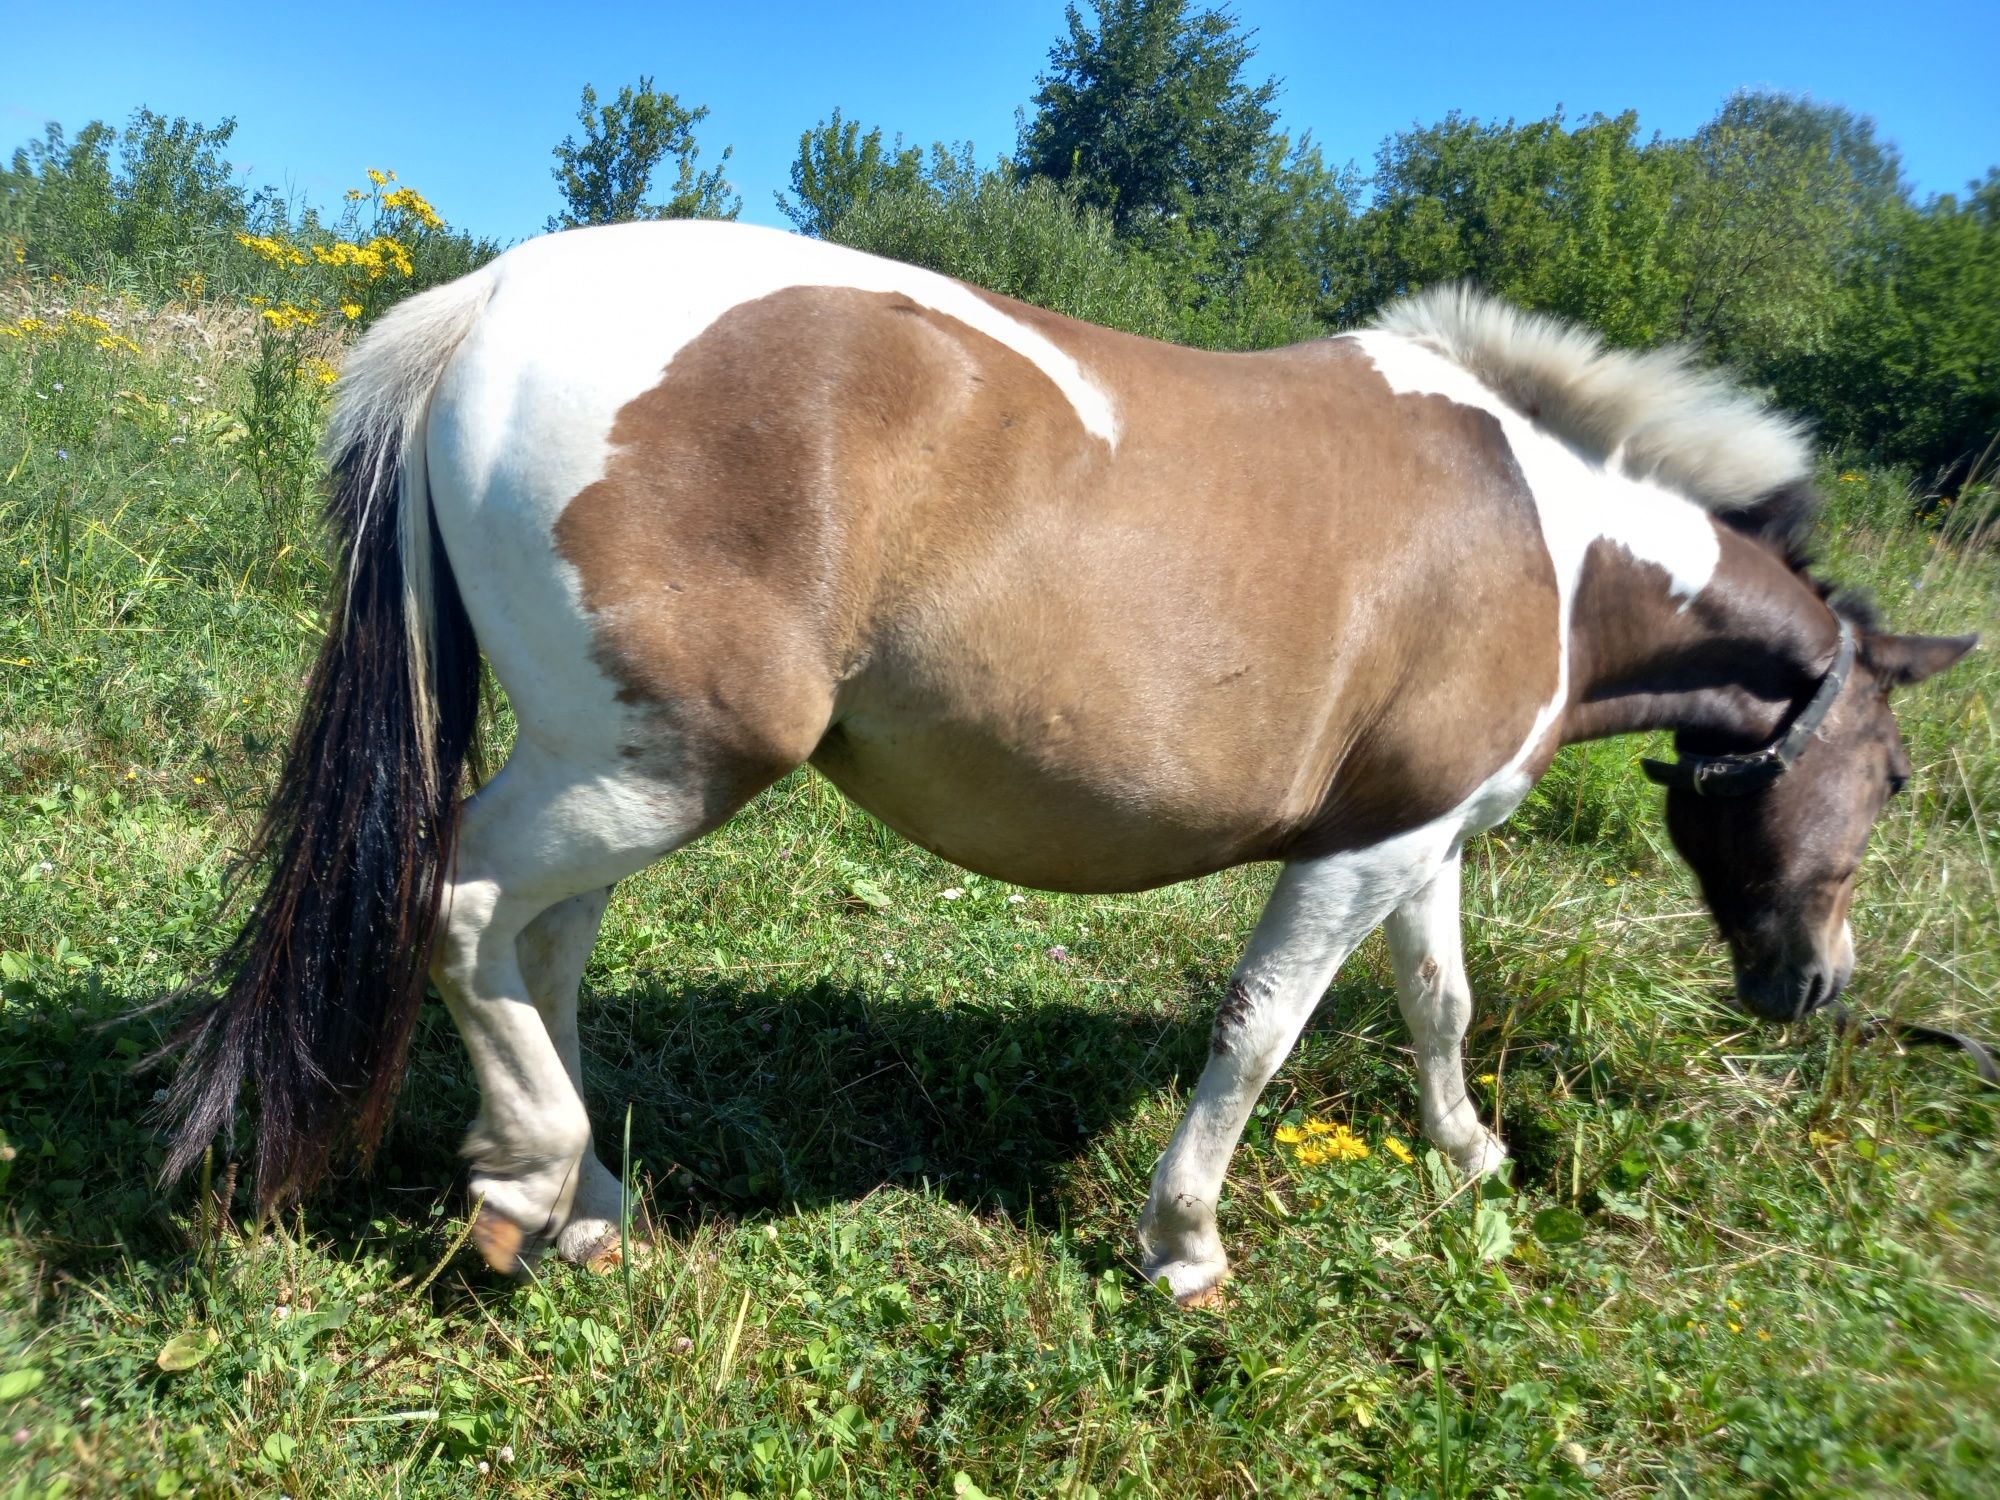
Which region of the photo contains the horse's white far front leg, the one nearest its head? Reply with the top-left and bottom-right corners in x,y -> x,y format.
1384,852 -> 1506,1176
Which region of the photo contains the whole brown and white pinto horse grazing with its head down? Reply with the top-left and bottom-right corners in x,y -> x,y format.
166,222 -> 1974,1302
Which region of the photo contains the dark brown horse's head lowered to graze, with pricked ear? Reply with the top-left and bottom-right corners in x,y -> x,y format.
1646,626 -> 1976,1020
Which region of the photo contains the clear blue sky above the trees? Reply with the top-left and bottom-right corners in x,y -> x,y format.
0,0 -> 2000,240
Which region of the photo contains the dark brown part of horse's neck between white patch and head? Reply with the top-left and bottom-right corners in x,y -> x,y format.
1562,526 -> 1840,748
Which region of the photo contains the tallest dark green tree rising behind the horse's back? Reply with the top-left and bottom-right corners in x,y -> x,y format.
1016,0 -> 1278,236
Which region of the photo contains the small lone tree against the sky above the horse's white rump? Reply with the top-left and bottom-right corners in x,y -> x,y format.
548,78 -> 742,230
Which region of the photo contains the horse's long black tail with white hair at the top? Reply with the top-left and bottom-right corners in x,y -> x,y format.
162,272 -> 492,1206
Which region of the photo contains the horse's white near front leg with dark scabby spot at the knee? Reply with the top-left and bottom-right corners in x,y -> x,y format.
1138,826 -> 1450,1302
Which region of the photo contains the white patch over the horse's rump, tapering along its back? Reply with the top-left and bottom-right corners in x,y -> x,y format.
428,220 -> 1118,764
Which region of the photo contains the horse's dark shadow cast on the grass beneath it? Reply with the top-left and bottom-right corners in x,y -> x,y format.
0,976 -> 1214,1270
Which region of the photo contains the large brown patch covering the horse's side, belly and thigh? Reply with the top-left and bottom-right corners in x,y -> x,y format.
556,286 -> 1560,890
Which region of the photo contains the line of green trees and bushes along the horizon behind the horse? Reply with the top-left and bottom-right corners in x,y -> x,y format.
0,0 -> 2000,486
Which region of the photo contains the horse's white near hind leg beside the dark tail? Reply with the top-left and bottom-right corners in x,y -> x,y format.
432,744 -> 704,1270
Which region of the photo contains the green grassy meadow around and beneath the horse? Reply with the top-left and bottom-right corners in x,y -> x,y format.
0,282 -> 2000,1498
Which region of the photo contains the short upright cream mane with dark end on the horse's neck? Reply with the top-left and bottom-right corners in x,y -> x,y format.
1374,286 -> 1818,566
